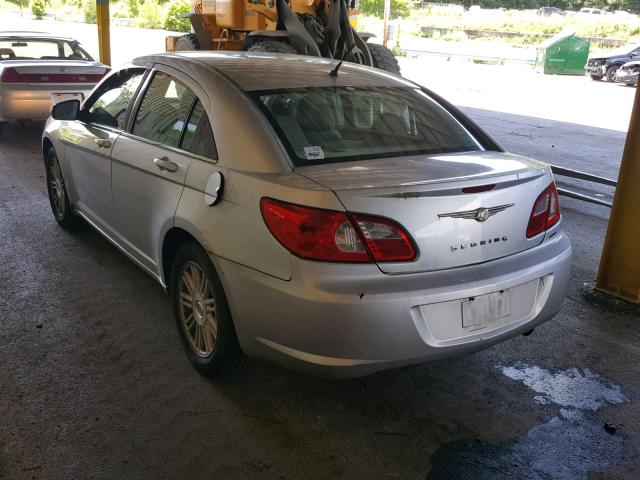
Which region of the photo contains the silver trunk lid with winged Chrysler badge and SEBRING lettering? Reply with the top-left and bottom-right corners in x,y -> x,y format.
296,152 -> 552,274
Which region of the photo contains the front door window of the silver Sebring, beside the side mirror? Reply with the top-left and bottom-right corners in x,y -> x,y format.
85,69 -> 144,130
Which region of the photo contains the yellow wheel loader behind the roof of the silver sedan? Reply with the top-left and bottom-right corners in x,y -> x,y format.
167,0 -> 400,73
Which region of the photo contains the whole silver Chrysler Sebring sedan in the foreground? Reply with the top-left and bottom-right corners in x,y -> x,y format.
42,52 -> 572,377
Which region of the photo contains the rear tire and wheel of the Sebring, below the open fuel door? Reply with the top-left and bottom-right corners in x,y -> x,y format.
170,242 -> 247,377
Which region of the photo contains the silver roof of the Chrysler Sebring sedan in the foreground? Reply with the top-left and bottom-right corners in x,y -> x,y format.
134,52 -> 416,91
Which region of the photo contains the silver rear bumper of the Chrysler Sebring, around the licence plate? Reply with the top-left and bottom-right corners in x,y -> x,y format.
218,227 -> 572,377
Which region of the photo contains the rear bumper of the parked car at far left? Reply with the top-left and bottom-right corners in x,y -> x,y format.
0,83 -> 93,122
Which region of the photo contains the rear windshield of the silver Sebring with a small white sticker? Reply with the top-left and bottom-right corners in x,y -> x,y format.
252,87 -> 482,166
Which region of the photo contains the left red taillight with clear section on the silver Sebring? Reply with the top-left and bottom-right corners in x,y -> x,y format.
260,198 -> 416,263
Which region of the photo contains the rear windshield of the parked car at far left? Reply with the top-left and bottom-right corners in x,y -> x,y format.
0,38 -> 93,61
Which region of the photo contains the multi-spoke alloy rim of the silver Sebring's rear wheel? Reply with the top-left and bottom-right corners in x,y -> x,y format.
178,261 -> 218,358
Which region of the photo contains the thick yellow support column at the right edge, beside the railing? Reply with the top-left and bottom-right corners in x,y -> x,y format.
596,80 -> 640,303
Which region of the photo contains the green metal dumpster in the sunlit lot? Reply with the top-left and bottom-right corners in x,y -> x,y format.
536,33 -> 589,75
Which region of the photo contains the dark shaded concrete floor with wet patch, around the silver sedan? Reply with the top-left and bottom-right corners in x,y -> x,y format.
0,62 -> 640,480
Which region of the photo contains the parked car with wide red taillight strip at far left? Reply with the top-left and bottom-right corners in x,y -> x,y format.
0,32 -> 109,136
